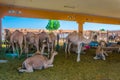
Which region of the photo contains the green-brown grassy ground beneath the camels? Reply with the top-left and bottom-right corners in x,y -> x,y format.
0,49 -> 120,80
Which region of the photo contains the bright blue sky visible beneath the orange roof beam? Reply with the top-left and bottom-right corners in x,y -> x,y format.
2,16 -> 120,30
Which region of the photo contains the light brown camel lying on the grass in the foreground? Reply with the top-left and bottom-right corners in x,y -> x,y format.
18,52 -> 58,72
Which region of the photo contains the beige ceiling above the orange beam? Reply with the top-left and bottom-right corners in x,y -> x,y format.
0,0 -> 120,18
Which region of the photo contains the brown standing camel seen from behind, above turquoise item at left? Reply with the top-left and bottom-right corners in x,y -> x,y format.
10,30 -> 26,57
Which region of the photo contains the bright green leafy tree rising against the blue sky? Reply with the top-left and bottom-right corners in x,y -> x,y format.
46,20 -> 60,30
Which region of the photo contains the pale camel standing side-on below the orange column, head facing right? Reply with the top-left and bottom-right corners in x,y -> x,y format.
65,31 -> 92,62
